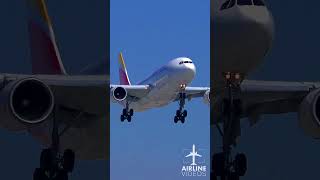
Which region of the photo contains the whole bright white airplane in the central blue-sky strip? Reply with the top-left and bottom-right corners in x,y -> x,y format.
110,53 -> 210,123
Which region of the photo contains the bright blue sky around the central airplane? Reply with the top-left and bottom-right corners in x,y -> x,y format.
110,0 -> 210,180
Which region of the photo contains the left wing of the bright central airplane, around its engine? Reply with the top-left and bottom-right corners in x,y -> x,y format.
110,85 -> 150,99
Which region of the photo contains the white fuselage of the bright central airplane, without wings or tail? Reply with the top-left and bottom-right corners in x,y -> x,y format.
120,57 -> 196,111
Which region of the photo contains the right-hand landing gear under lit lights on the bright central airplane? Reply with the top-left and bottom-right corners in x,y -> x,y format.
174,84 -> 188,123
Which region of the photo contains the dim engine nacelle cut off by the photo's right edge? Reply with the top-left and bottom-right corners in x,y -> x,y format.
299,89 -> 320,138
